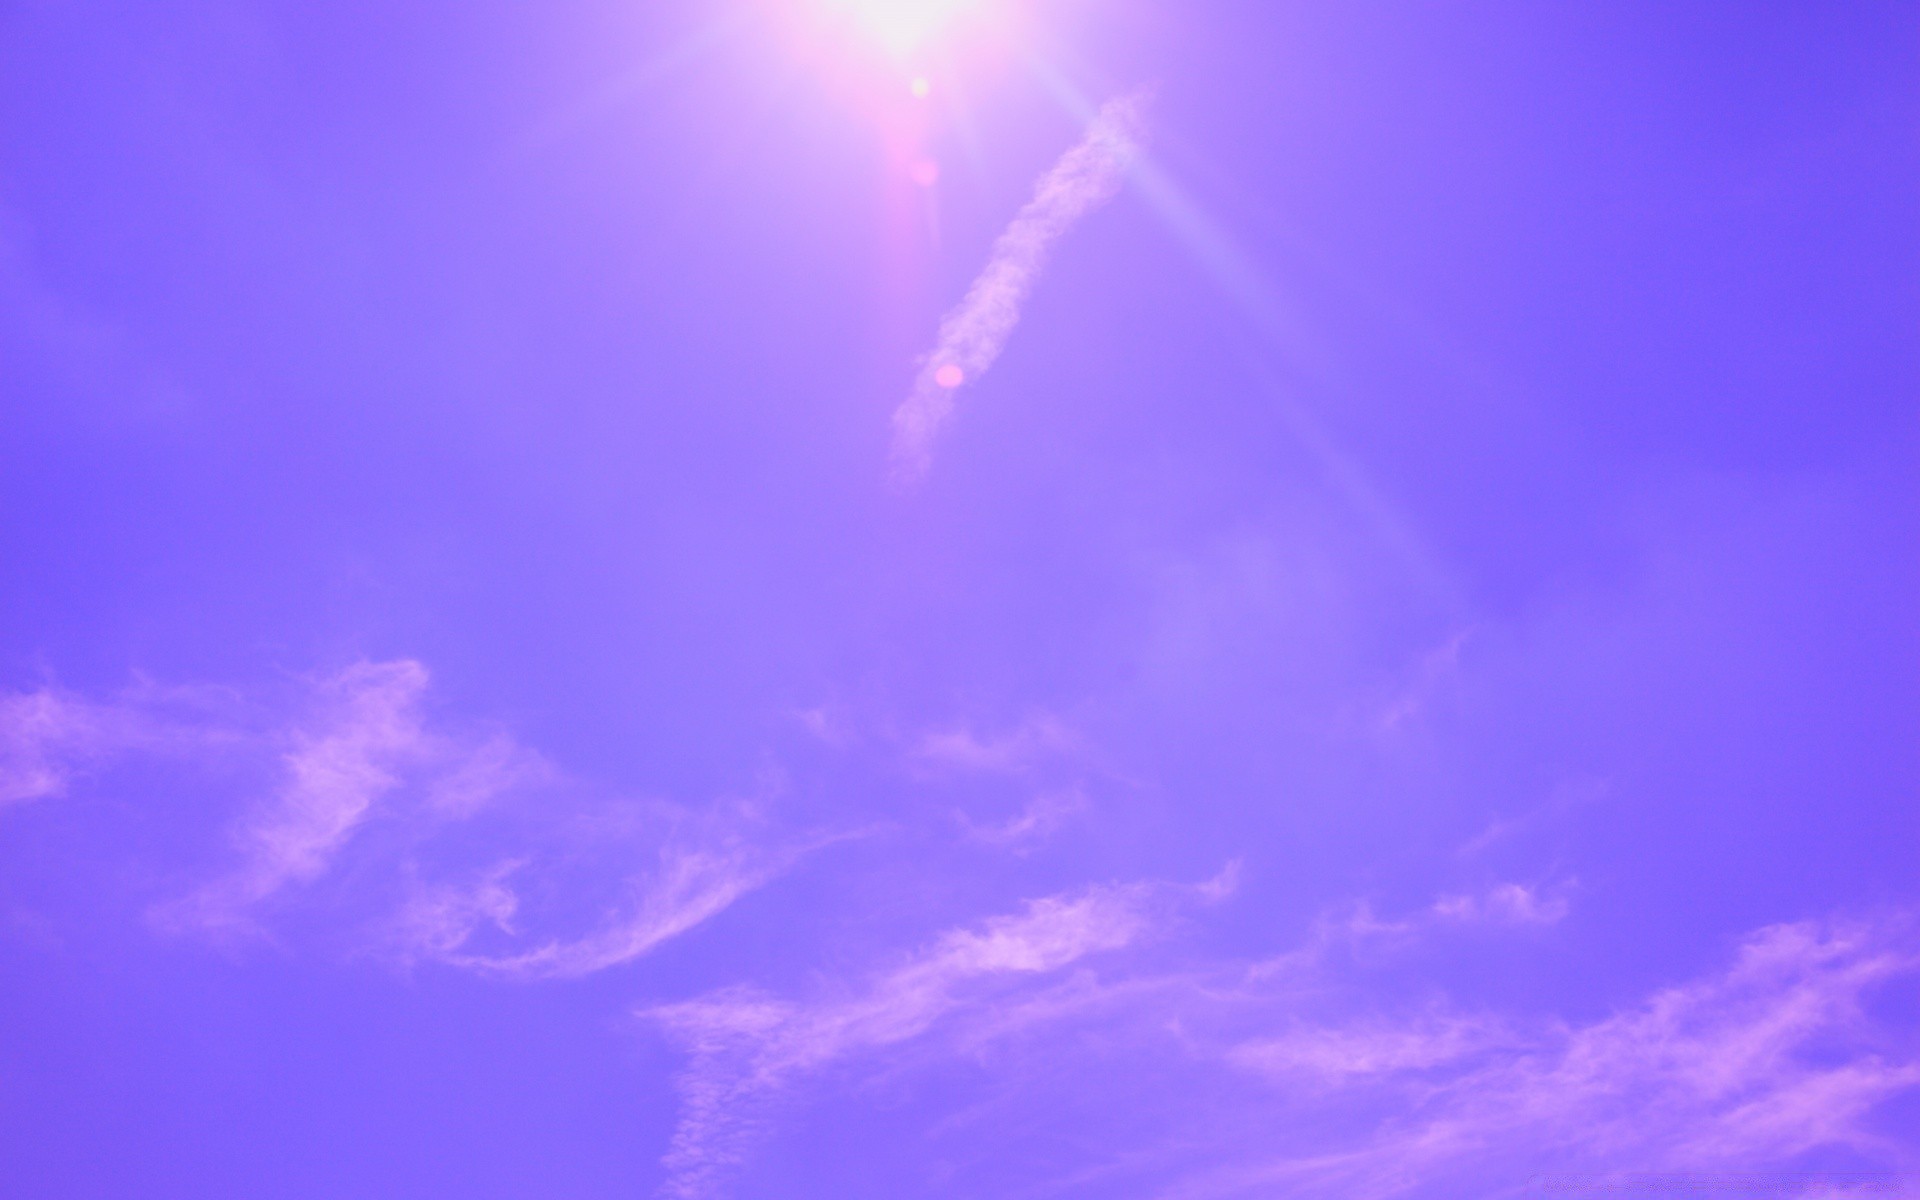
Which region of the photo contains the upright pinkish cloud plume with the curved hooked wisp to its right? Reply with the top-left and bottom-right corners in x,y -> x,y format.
156,659 -> 801,960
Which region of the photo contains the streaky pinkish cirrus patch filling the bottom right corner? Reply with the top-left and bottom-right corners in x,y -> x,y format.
1173,918 -> 1920,1196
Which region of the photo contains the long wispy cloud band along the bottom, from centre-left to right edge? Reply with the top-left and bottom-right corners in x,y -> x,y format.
645,875 -> 1920,1198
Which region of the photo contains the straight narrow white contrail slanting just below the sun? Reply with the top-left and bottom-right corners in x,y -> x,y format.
893,92 -> 1146,482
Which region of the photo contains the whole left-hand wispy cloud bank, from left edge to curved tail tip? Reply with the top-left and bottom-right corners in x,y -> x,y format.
0,659 -> 794,967
